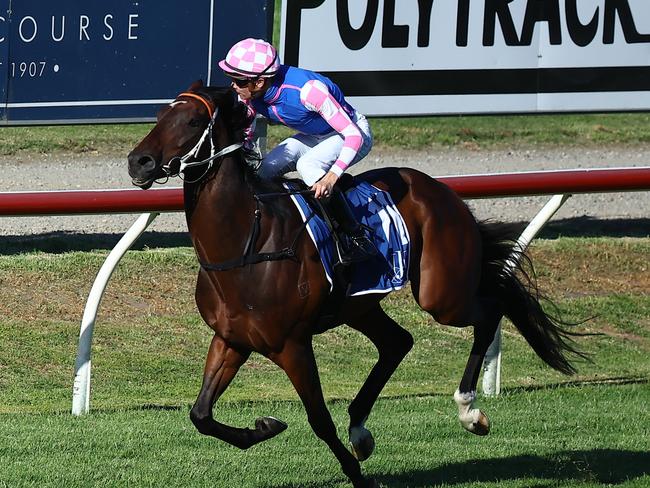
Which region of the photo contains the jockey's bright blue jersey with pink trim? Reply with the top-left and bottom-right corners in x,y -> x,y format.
251,65 -> 355,135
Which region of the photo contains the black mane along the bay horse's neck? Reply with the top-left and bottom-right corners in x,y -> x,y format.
193,86 -> 304,218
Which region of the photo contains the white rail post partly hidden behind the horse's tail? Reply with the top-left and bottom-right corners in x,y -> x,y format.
483,195 -> 571,396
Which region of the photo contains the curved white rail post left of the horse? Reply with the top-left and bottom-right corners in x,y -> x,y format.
72,212 -> 159,415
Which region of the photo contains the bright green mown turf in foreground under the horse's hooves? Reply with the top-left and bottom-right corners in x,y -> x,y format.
0,385 -> 650,488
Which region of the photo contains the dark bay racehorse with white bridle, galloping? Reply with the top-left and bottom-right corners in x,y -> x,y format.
128,82 -> 582,487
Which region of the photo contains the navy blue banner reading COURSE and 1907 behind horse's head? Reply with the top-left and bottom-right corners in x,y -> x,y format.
0,0 -> 273,125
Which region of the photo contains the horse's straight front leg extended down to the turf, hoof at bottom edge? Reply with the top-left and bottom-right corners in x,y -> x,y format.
272,342 -> 377,488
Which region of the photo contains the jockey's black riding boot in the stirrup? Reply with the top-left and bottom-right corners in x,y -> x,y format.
325,186 -> 378,264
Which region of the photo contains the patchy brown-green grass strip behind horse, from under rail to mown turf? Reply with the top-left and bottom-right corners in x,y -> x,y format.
0,238 -> 650,413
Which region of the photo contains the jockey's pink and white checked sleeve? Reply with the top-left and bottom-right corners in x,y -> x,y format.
300,80 -> 363,176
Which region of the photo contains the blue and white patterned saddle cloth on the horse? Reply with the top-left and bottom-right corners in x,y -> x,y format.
285,181 -> 410,296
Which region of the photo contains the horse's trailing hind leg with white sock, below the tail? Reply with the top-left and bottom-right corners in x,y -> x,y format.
454,300 -> 502,435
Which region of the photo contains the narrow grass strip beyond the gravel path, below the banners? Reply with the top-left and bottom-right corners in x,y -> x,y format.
5,113 -> 650,156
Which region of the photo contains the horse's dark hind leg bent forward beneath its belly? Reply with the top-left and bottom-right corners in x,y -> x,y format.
348,305 -> 413,461
